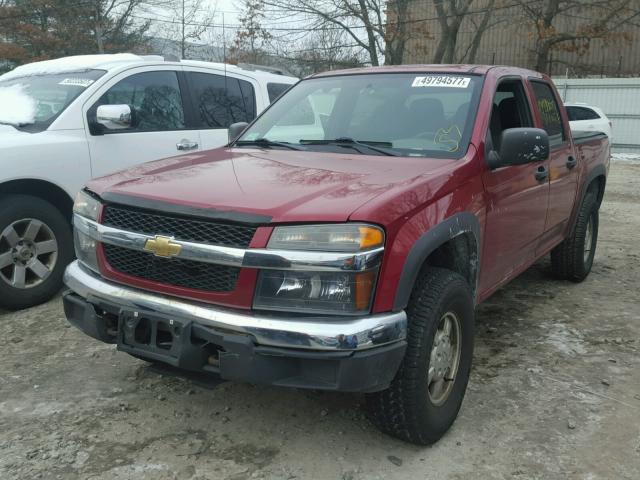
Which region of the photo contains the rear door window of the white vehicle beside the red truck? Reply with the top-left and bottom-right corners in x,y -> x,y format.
188,73 -> 256,128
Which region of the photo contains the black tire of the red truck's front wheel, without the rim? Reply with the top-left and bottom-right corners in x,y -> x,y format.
366,268 -> 474,445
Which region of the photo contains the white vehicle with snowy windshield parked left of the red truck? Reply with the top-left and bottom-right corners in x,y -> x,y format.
0,54 -> 297,309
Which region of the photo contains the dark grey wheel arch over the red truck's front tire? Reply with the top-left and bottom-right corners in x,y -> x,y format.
393,212 -> 480,310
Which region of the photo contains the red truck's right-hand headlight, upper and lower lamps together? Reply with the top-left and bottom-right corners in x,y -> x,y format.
253,223 -> 384,315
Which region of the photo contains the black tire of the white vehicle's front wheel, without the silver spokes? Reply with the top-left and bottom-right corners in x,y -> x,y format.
0,195 -> 74,310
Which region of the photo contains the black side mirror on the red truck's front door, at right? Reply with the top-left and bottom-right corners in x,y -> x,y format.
487,128 -> 549,170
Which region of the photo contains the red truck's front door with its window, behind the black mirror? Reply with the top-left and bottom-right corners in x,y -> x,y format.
480,78 -> 549,295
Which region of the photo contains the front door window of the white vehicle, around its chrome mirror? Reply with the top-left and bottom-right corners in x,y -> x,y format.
89,71 -> 185,133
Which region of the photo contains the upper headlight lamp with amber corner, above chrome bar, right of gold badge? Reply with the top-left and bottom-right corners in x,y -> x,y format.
267,223 -> 384,252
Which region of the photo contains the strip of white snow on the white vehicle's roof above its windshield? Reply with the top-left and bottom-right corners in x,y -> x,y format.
0,53 -> 142,81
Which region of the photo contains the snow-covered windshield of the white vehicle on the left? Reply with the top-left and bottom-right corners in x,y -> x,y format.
0,70 -> 105,132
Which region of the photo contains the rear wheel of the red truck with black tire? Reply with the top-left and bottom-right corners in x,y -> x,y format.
551,189 -> 599,282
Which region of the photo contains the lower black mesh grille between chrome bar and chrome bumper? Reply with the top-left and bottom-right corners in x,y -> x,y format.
104,243 -> 240,292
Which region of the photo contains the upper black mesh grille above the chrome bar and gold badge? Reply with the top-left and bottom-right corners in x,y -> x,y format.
103,205 -> 256,248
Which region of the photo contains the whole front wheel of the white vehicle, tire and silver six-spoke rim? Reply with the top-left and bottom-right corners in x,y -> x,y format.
0,195 -> 73,310
